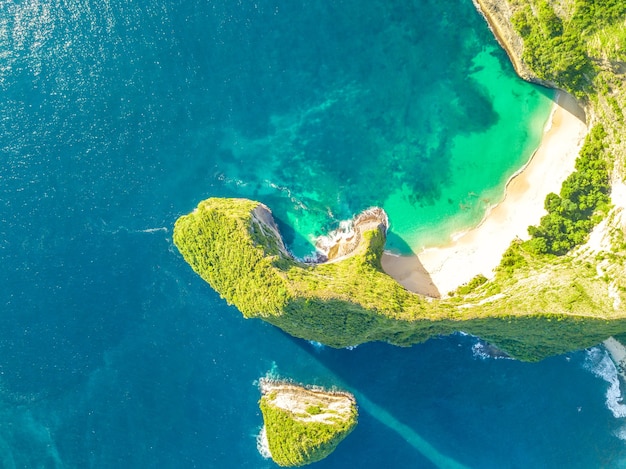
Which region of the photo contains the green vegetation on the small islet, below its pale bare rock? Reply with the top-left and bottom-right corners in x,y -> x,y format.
259,385 -> 357,466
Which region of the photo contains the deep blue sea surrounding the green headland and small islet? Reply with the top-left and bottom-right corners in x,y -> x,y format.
0,0 -> 626,468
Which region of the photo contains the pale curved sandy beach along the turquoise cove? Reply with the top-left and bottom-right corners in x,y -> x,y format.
382,92 -> 587,297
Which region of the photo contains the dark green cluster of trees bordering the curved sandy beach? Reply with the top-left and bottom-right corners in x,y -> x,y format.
525,124 -> 611,256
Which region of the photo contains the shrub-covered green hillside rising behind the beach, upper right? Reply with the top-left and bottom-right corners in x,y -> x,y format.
492,0 -> 626,278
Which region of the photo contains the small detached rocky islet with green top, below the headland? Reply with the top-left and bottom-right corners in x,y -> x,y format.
259,378 -> 358,467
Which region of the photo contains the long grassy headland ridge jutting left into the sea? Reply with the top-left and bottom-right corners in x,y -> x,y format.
174,198 -> 626,361
